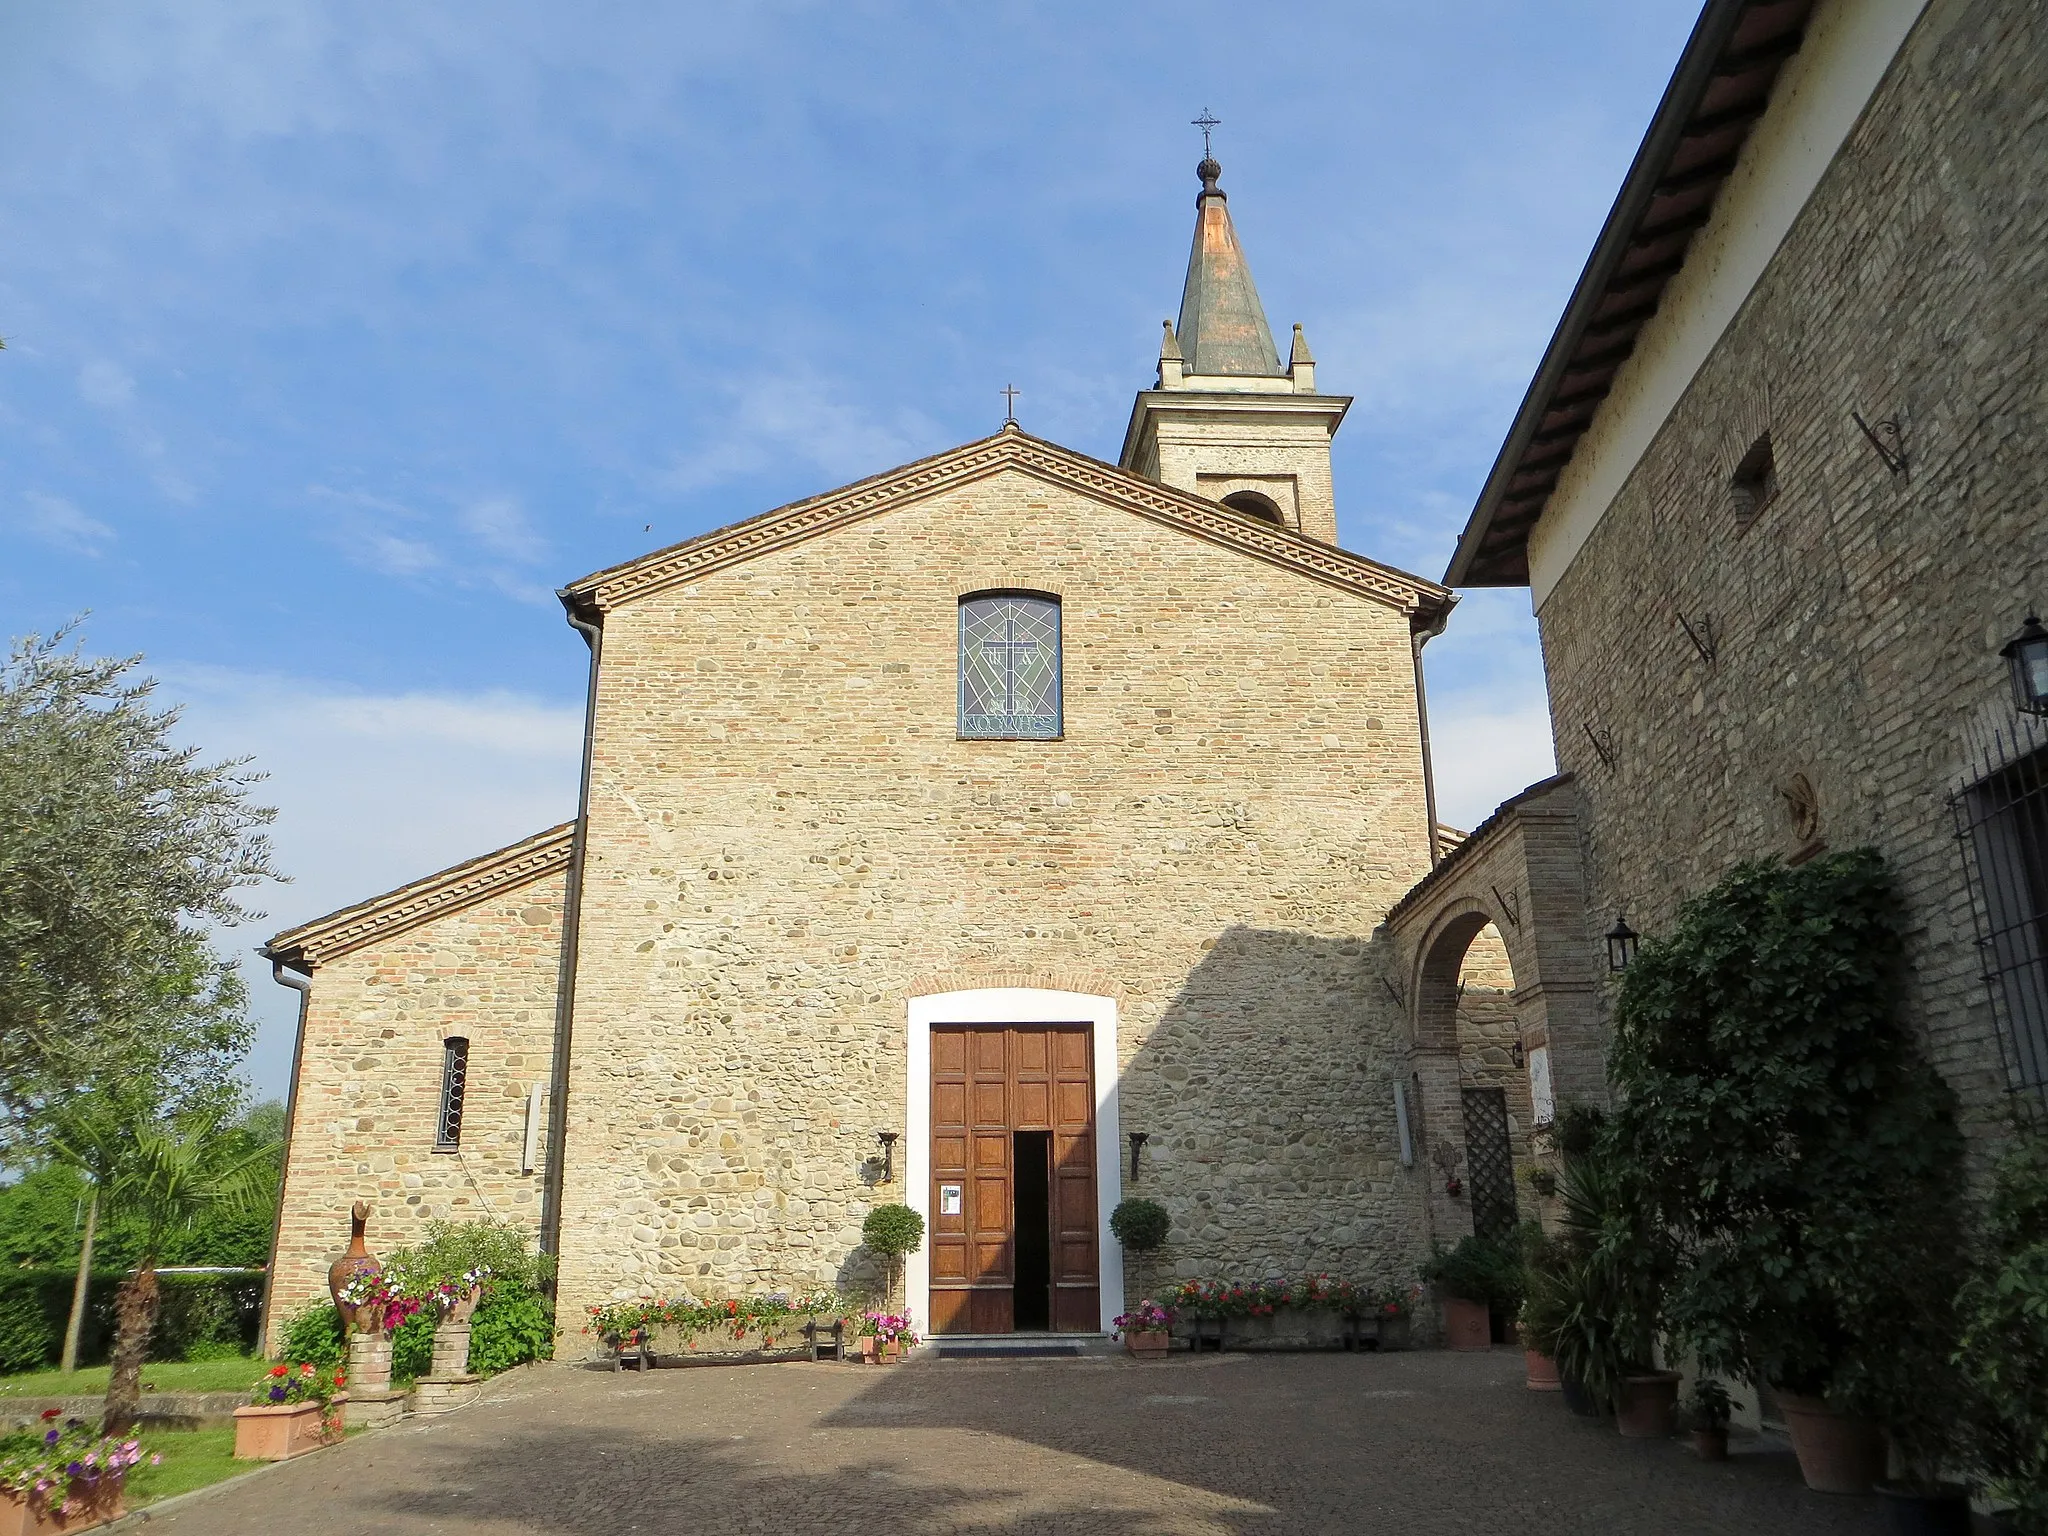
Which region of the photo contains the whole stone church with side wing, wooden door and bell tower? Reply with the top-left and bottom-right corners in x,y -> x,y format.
268,160 -> 1474,1337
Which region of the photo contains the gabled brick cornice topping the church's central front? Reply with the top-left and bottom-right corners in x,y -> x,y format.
561,423 -> 1452,629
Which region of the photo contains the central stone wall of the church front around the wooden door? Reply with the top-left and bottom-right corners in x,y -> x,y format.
561,471 -> 1427,1319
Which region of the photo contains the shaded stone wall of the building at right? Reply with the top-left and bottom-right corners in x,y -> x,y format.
1540,0 -> 2048,1137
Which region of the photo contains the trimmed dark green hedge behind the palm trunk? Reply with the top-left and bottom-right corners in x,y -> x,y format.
0,1268 -> 264,1374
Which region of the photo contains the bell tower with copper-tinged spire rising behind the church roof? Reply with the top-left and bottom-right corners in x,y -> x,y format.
1118,156 -> 1352,545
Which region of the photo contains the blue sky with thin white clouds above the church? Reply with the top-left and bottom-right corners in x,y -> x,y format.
0,0 -> 1698,1092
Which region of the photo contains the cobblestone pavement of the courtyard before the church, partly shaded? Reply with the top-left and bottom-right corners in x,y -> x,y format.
136,1350 -> 1880,1536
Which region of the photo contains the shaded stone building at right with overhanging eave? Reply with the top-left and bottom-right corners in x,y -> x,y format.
1425,0 -> 2048,1145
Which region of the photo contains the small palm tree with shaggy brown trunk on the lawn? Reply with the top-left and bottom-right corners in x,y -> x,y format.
104,1110 -> 276,1436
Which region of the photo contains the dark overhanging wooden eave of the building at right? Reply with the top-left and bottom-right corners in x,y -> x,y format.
1444,0 -> 1815,588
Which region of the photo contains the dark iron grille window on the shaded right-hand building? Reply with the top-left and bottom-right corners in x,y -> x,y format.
1954,748 -> 2048,1108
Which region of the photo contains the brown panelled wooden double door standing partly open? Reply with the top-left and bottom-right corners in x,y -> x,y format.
930,1024 -> 1102,1333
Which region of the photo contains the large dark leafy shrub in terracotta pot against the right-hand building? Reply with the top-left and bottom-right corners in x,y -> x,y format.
1604,848 -> 1964,1493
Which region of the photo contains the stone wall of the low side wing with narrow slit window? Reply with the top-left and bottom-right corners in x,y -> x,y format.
270,872 -> 563,1339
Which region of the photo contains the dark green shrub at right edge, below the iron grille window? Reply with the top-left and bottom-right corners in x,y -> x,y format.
1956,1133 -> 2048,1536
